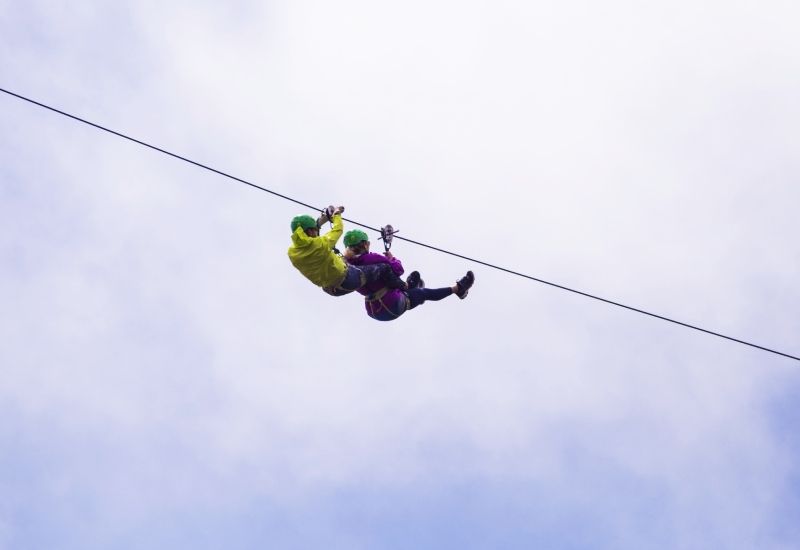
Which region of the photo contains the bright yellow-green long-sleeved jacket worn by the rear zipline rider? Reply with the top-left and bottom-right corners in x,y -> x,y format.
289,214 -> 347,287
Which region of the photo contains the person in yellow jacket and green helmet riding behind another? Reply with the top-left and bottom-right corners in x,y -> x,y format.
288,206 -> 406,296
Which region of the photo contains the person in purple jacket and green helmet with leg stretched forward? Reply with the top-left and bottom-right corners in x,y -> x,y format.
344,229 -> 475,321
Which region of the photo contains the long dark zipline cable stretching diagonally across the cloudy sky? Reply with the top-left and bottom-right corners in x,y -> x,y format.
0,88 -> 800,361
